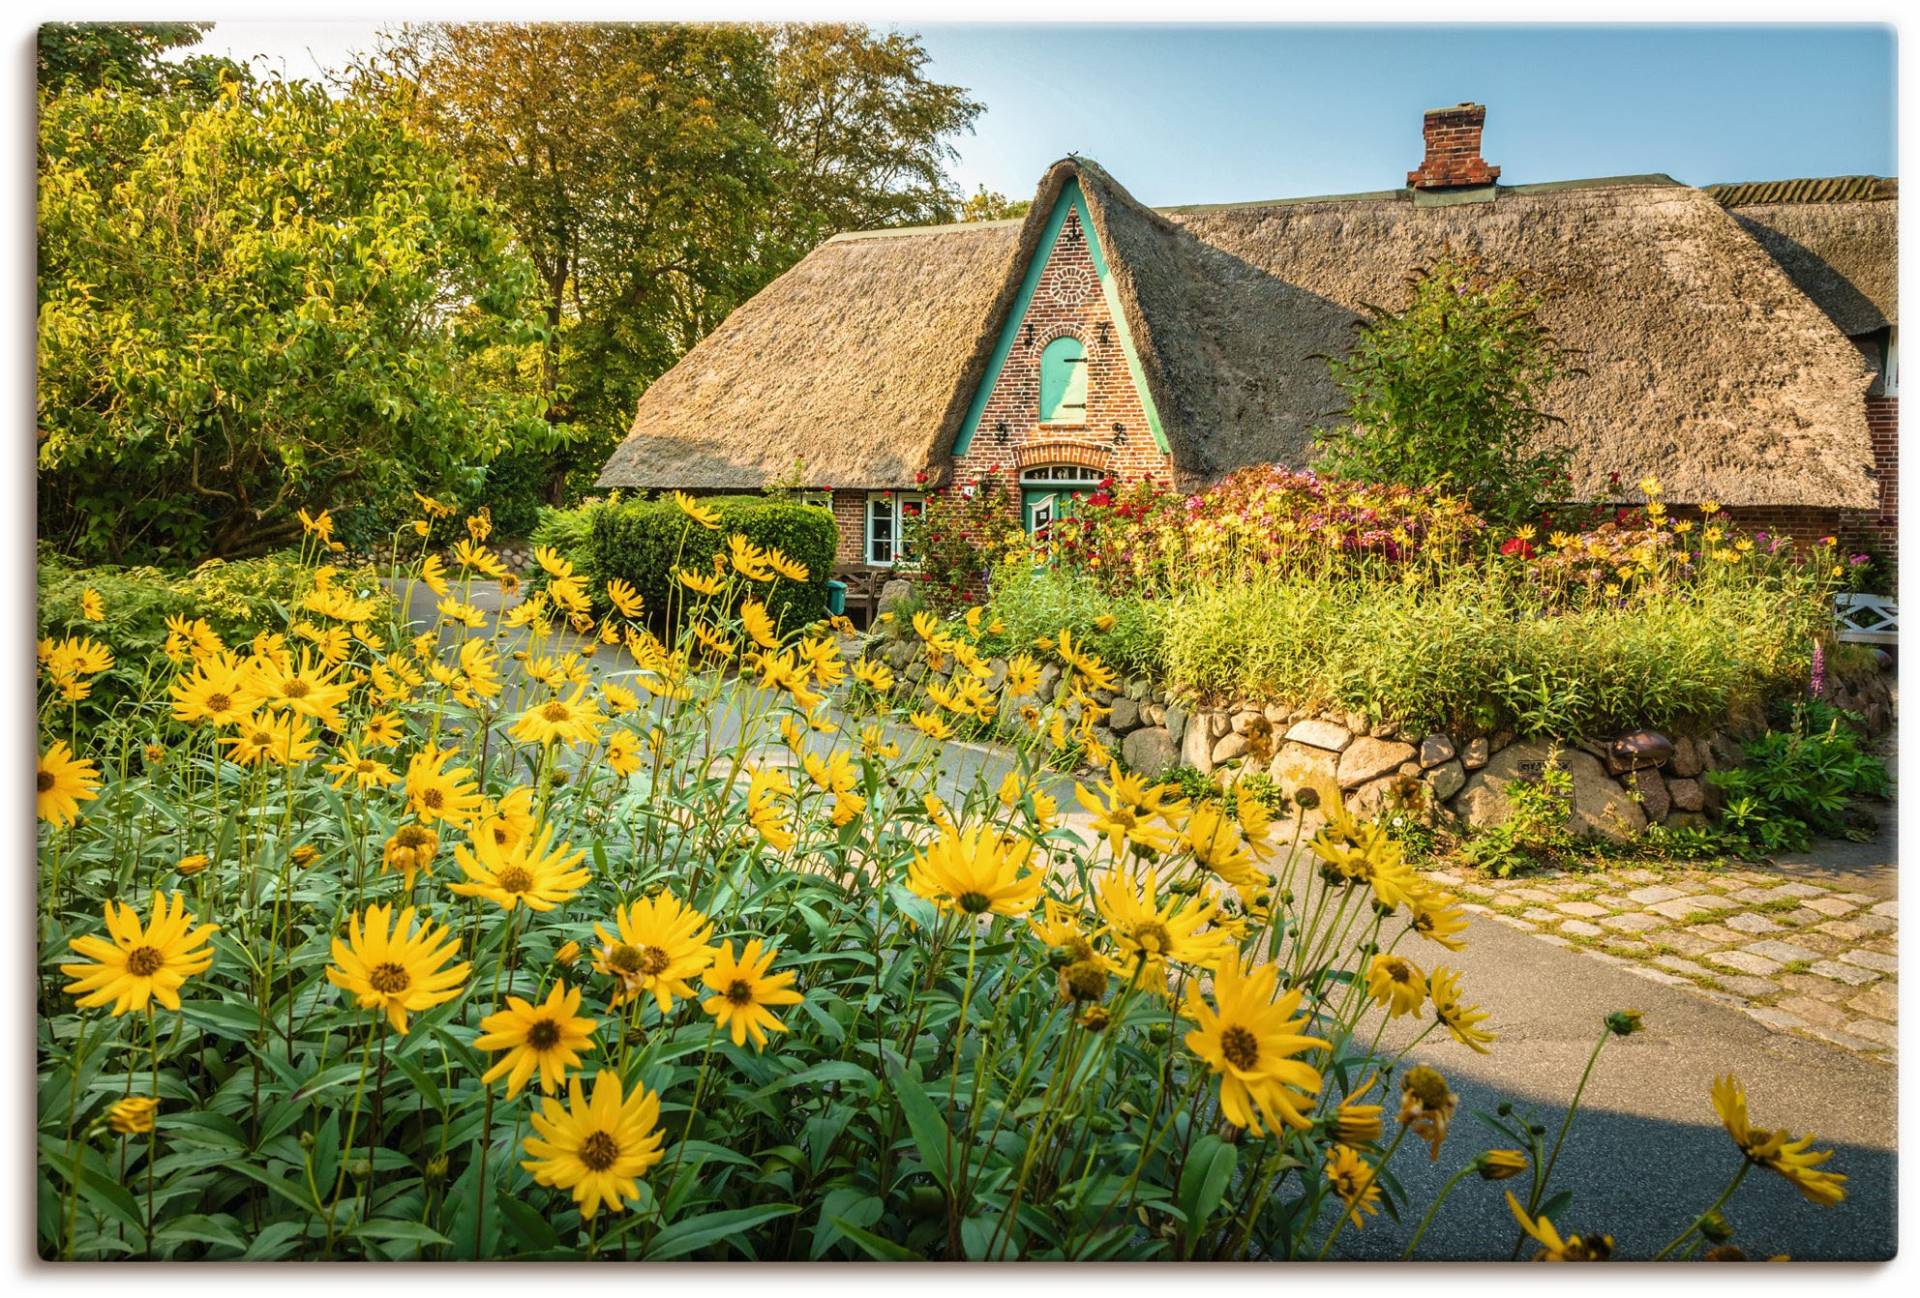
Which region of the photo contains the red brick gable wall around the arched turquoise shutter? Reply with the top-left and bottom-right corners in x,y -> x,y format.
950,200 -> 1173,526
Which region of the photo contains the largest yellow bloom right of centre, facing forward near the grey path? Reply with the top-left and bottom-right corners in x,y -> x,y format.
1187,962 -> 1327,1135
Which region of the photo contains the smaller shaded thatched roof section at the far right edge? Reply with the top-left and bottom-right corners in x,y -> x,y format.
1707,177 -> 1899,336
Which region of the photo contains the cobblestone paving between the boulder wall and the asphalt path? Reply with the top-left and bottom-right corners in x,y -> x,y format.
1427,868 -> 1899,1064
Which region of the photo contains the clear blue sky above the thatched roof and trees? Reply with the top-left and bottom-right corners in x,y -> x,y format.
187,23 -> 1897,205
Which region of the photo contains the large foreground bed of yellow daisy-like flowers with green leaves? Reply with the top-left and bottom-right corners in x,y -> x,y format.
35,501 -> 1845,1260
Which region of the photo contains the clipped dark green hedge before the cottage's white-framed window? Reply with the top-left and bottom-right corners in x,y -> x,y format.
588,495 -> 839,628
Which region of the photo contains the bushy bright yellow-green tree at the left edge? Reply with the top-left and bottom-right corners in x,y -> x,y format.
38,81 -> 547,559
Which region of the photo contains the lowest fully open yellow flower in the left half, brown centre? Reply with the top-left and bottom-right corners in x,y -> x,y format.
520,1068 -> 666,1221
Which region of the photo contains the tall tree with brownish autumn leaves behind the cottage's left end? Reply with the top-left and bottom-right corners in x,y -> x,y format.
372,23 -> 981,501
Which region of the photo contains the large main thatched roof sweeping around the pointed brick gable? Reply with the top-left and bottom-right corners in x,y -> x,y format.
601,157 -> 1876,507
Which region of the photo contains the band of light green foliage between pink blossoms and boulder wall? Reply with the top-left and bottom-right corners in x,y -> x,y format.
1148,566 -> 1824,737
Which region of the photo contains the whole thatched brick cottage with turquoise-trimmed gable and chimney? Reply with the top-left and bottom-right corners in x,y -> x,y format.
601,104 -> 1897,565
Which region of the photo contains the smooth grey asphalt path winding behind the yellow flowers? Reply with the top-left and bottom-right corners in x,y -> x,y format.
397,576 -> 1897,1260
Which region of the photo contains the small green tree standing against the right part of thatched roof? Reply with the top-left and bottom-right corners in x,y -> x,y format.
1315,253 -> 1569,524
